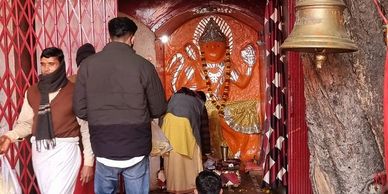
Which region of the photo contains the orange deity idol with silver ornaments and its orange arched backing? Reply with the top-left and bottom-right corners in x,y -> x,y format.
164,14 -> 265,161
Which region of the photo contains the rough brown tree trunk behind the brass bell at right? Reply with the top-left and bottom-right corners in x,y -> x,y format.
302,0 -> 388,194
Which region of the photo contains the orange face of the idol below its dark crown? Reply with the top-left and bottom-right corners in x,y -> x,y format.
199,41 -> 226,63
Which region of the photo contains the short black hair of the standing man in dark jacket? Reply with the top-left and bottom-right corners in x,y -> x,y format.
108,17 -> 137,38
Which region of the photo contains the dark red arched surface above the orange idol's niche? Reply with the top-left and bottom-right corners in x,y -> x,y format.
118,0 -> 266,34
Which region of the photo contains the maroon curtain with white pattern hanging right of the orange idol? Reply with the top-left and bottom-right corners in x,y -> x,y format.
263,0 -> 287,188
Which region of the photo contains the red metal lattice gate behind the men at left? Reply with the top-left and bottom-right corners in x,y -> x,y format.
0,0 -> 117,193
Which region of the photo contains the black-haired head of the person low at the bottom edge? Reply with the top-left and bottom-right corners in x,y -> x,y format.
195,170 -> 222,194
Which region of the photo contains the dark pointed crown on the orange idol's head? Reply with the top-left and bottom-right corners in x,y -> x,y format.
199,18 -> 226,43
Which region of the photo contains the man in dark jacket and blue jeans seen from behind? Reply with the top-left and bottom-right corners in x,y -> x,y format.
73,17 -> 166,194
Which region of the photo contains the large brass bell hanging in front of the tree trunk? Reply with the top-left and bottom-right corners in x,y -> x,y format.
280,0 -> 358,68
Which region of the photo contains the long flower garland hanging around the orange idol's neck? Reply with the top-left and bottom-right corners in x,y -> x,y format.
201,47 -> 231,117
